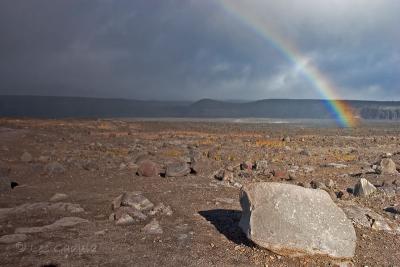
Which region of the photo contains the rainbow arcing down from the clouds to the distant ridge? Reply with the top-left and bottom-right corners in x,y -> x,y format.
219,0 -> 357,127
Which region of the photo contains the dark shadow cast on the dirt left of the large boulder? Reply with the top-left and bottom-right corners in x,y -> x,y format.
199,209 -> 255,247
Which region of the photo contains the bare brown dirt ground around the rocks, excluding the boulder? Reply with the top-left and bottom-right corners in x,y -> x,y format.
0,119 -> 400,266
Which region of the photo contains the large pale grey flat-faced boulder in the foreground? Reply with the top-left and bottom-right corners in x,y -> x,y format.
239,183 -> 356,258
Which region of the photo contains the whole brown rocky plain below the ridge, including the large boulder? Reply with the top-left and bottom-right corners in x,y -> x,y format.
0,119 -> 400,266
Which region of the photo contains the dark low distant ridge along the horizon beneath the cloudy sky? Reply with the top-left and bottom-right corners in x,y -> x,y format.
0,95 -> 400,120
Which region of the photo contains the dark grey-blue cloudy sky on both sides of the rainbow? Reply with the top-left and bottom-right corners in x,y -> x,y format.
0,0 -> 400,100
